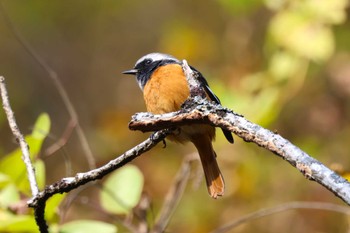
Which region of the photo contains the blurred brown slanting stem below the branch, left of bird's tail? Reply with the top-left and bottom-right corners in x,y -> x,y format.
151,154 -> 198,233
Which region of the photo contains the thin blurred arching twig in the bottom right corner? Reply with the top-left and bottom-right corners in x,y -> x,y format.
211,201 -> 350,233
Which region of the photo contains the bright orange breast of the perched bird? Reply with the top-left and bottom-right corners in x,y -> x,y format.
143,64 -> 190,114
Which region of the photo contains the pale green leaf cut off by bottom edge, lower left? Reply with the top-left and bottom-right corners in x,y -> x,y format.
59,220 -> 117,233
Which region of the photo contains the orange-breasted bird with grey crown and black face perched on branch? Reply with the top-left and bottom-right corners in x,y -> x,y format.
122,53 -> 234,199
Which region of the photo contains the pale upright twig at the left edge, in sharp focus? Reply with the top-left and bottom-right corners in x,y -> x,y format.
0,76 -> 39,196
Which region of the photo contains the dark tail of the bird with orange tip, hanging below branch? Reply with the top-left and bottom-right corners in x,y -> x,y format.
191,134 -> 225,199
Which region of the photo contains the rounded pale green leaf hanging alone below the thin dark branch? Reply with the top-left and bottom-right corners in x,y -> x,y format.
100,165 -> 143,214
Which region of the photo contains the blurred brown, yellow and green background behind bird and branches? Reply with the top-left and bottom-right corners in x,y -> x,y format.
0,0 -> 350,232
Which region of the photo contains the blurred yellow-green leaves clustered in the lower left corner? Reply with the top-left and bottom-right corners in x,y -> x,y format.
0,113 -> 54,232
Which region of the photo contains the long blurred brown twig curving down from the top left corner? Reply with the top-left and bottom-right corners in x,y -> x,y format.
0,1 -> 96,169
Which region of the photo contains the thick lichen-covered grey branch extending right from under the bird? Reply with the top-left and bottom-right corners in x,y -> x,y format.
129,62 -> 350,205
